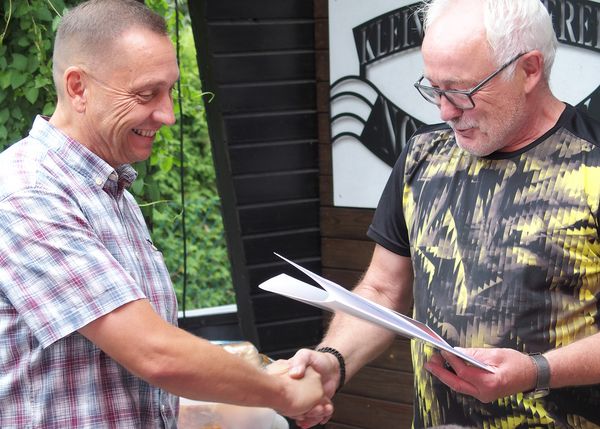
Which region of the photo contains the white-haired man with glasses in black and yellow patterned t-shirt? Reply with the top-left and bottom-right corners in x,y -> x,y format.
291,0 -> 600,428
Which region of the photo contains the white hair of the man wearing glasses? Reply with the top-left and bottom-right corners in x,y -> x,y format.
422,0 -> 558,80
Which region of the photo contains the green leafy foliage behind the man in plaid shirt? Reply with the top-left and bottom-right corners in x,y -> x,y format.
0,0 -> 235,310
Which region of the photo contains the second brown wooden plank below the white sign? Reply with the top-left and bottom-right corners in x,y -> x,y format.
321,238 -> 375,271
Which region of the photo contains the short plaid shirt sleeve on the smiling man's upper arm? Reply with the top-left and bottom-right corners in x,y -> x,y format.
0,189 -> 145,347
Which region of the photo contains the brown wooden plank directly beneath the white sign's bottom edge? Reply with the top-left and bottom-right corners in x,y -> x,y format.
321,207 -> 373,240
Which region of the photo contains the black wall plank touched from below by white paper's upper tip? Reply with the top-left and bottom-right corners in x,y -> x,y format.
243,228 -> 321,264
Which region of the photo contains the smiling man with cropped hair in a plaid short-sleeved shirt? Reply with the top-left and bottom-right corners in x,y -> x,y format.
0,0 -> 331,429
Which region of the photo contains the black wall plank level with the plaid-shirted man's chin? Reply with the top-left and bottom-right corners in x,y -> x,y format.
230,140 -> 319,175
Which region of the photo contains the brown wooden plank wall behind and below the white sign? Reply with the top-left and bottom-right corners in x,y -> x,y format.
314,0 -> 413,429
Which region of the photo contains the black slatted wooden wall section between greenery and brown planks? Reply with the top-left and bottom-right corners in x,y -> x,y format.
188,0 -> 322,358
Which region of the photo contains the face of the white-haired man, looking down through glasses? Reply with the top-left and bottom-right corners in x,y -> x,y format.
421,1 -> 527,156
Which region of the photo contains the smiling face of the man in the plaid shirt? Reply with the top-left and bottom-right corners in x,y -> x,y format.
77,28 -> 179,167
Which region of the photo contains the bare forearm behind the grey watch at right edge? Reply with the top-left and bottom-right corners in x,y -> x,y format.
544,333 -> 600,388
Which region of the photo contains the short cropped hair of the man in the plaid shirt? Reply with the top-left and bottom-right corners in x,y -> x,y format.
52,0 -> 168,93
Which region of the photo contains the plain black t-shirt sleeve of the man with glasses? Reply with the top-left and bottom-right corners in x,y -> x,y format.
367,140 -> 410,256
